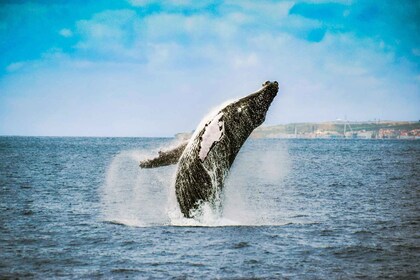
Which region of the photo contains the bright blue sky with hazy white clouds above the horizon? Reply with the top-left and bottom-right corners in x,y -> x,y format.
0,0 -> 420,137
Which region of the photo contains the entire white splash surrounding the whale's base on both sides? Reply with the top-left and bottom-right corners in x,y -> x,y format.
100,139 -> 294,227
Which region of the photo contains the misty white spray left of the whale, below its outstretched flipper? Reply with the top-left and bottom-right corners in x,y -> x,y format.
101,150 -> 174,226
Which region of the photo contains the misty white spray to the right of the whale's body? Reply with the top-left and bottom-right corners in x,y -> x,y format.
223,140 -> 292,225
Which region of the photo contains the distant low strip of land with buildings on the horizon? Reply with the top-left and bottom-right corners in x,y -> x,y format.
176,121 -> 420,140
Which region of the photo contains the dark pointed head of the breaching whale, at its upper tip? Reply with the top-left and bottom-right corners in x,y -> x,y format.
232,81 -> 279,128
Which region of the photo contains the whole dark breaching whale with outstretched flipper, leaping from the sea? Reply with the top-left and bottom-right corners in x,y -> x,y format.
140,81 -> 278,218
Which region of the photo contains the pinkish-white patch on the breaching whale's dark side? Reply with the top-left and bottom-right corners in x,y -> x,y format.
199,113 -> 225,161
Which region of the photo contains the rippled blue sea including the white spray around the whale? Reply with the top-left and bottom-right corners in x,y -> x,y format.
0,137 -> 420,279
